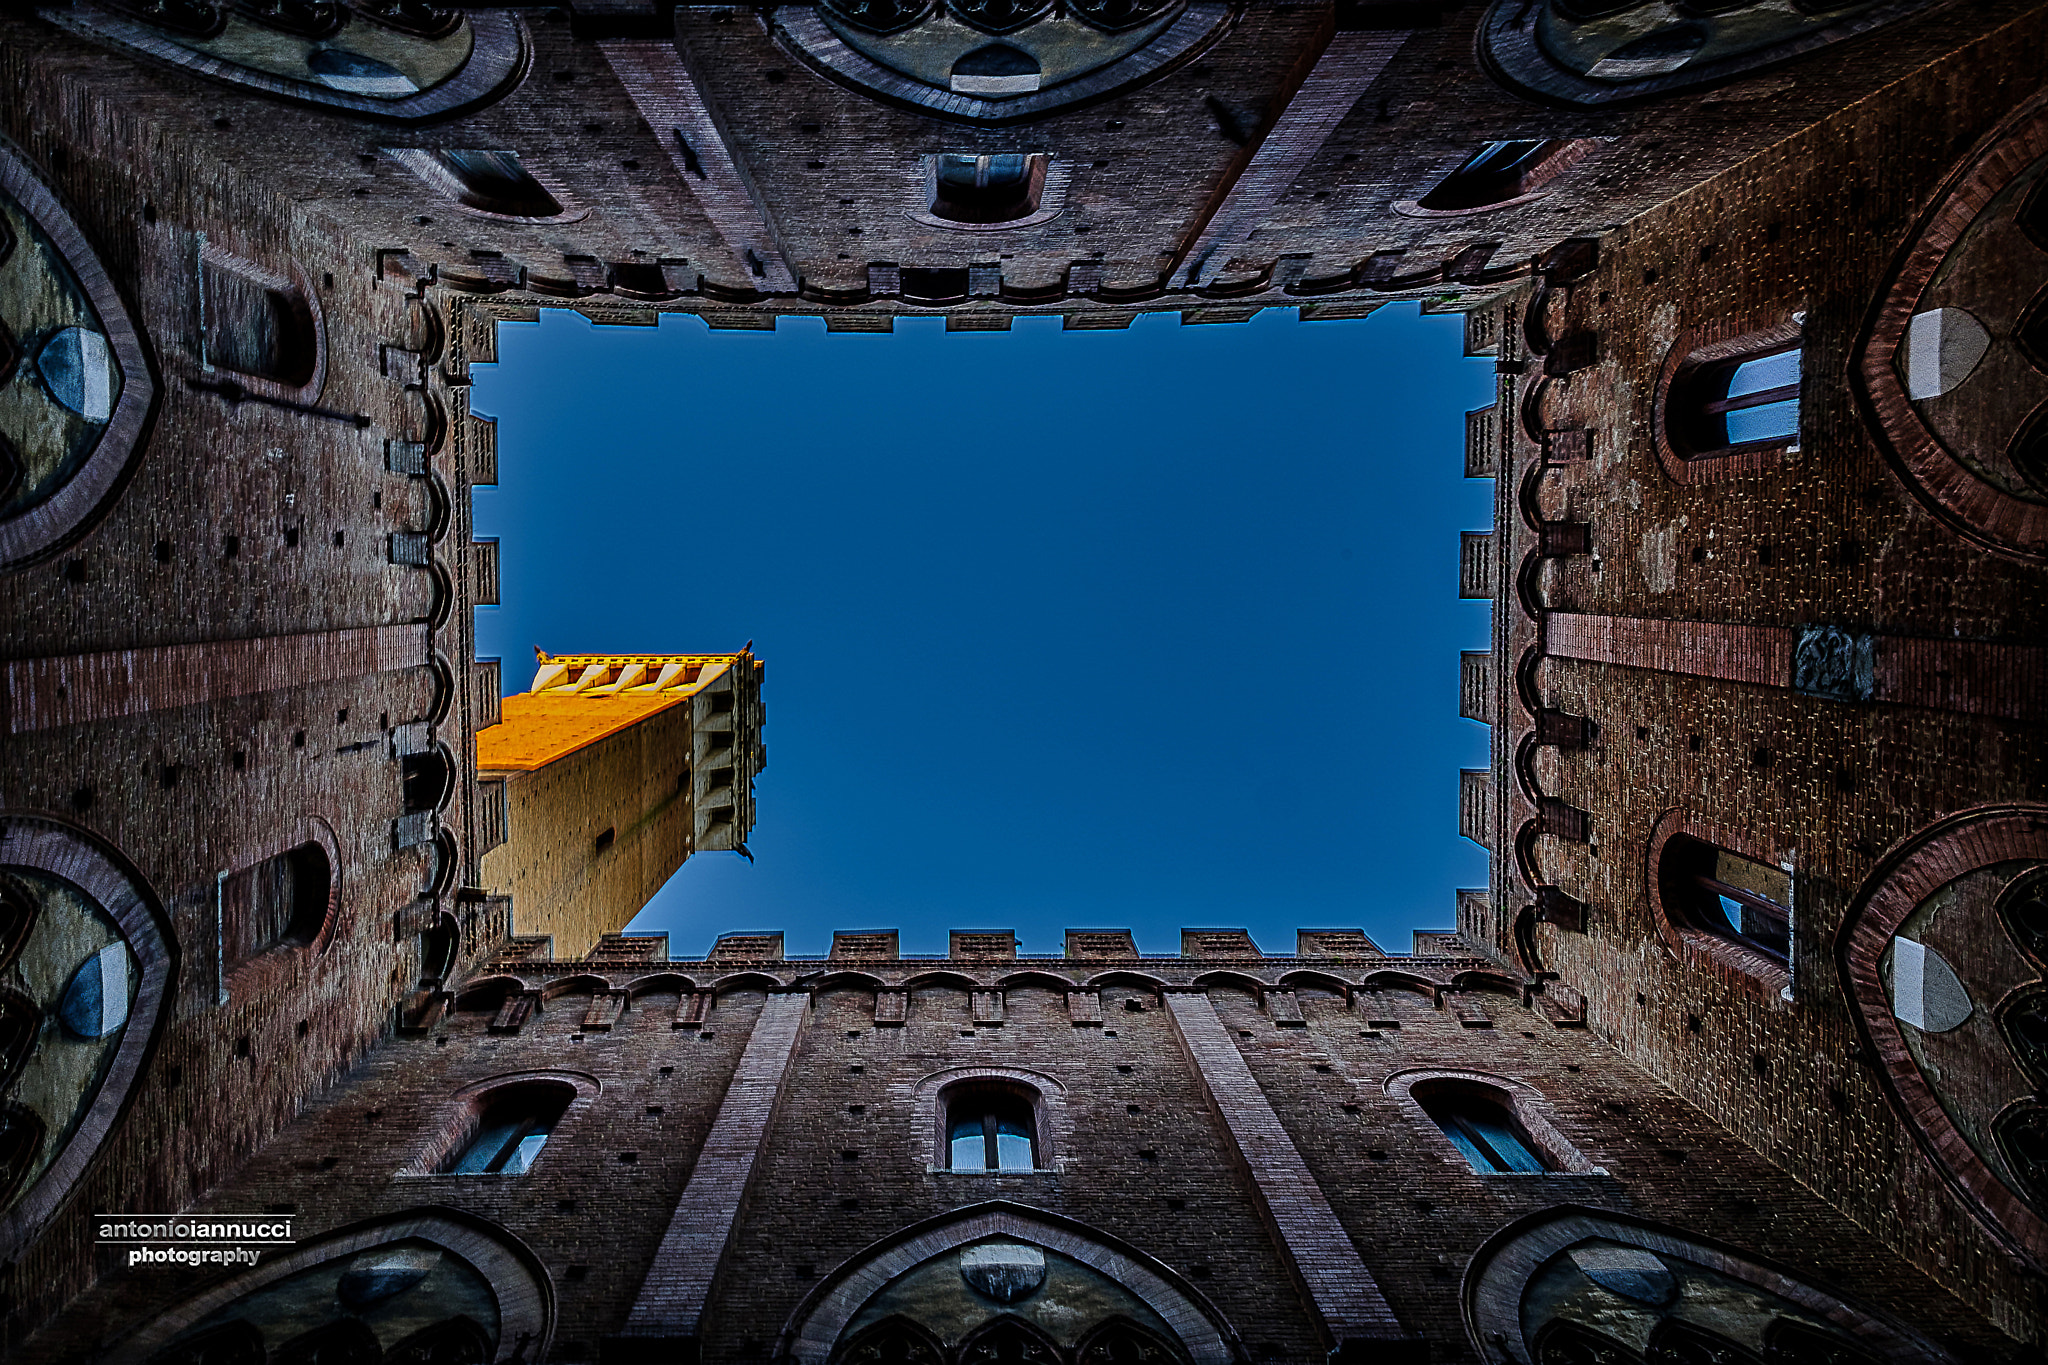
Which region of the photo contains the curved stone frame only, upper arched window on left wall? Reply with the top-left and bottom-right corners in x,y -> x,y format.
0,139 -> 158,571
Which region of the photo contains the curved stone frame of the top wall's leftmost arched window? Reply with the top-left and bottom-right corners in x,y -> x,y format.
37,4 -> 532,123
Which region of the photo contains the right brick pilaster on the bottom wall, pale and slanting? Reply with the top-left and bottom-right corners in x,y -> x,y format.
1165,990 -> 1419,1361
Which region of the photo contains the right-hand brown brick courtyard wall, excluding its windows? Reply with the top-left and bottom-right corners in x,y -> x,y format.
1473,10 -> 2048,1336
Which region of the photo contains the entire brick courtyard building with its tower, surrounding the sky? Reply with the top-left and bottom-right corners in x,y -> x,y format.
0,0 -> 2048,1365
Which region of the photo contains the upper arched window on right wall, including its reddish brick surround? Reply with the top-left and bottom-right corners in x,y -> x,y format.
1851,96 -> 2048,563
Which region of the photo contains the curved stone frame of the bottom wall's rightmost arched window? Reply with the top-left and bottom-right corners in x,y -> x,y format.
1460,1203 -> 1956,1365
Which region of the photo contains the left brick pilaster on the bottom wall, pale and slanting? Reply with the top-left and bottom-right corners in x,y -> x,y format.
606,993 -> 811,1357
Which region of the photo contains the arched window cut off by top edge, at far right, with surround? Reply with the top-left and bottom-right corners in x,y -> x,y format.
1481,0 -> 1933,104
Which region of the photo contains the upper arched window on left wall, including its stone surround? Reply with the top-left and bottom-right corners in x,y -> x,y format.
0,141 -> 156,571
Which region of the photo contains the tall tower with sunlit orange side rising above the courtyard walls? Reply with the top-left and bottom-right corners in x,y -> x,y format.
477,651 -> 766,956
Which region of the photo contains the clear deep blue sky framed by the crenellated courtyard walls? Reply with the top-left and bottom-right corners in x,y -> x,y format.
473,305 -> 1493,956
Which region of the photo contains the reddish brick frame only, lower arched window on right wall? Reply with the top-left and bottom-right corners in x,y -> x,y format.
1835,802 -> 2048,1263
